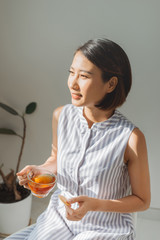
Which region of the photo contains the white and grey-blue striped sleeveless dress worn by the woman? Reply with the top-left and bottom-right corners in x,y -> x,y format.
8,104 -> 135,240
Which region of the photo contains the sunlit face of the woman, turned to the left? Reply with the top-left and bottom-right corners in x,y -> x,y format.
68,51 -> 107,107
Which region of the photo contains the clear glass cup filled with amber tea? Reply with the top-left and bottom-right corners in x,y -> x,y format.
27,170 -> 56,198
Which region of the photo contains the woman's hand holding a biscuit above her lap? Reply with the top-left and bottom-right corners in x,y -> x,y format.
65,196 -> 95,221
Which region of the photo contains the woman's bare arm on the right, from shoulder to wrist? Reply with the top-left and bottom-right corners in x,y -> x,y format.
92,128 -> 151,212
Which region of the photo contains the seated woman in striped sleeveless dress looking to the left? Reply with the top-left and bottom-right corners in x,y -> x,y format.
5,39 -> 150,240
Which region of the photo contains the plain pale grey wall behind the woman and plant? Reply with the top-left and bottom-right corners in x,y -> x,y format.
0,0 -> 160,208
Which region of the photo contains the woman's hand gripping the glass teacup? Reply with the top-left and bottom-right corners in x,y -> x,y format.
16,165 -> 44,189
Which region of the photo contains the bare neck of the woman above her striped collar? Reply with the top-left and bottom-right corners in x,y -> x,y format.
83,107 -> 115,128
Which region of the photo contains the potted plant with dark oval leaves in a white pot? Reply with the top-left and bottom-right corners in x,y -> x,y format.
0,102 -> 37,236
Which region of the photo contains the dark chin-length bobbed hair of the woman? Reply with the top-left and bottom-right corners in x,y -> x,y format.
76,39 -> 132,110
